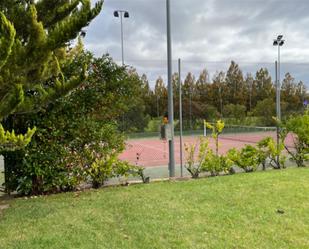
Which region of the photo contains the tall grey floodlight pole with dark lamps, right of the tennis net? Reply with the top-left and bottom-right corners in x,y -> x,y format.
273,35 -> 284,168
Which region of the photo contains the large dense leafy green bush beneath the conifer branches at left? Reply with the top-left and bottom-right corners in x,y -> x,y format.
6,53 -> 144,194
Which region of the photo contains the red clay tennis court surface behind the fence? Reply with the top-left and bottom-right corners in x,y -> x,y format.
119,132 -> 293,167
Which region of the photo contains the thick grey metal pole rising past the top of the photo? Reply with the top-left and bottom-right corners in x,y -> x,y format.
166,0 -> 175,177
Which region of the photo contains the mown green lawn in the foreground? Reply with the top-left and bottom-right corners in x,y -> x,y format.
0,168 -> 309,249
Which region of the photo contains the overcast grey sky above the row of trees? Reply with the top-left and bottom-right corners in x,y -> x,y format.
85,0 -> 309,86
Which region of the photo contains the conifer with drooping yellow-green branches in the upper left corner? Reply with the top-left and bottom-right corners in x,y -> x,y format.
0,0 -> 103,119
